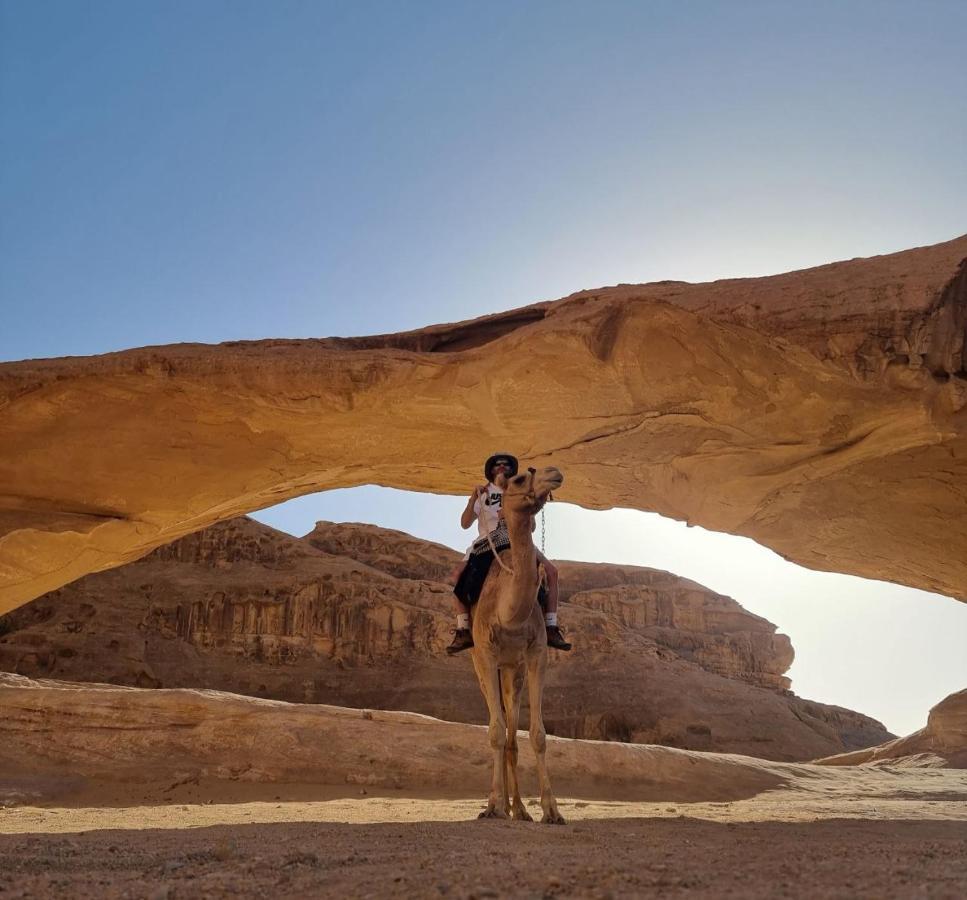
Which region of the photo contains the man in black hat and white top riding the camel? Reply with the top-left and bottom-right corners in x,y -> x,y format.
447,453 -> 571,656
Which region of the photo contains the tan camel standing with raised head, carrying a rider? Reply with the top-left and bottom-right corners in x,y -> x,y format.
471,467 -> 564,825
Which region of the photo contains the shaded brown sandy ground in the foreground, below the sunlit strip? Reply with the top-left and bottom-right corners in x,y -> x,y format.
0,804 -> 967,898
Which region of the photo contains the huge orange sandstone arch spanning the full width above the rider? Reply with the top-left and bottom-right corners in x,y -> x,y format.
0,236 -> 967,612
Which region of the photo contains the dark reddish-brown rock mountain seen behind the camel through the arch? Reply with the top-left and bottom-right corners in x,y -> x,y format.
0,518 -> 893,760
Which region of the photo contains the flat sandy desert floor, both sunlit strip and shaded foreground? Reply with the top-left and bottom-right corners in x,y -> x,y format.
0,768 -> 967,898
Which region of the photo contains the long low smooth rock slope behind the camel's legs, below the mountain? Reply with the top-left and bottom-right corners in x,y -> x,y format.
0,673 -> 802,801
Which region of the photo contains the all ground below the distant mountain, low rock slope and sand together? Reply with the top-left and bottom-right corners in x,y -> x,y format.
0,676 -> 967,900
